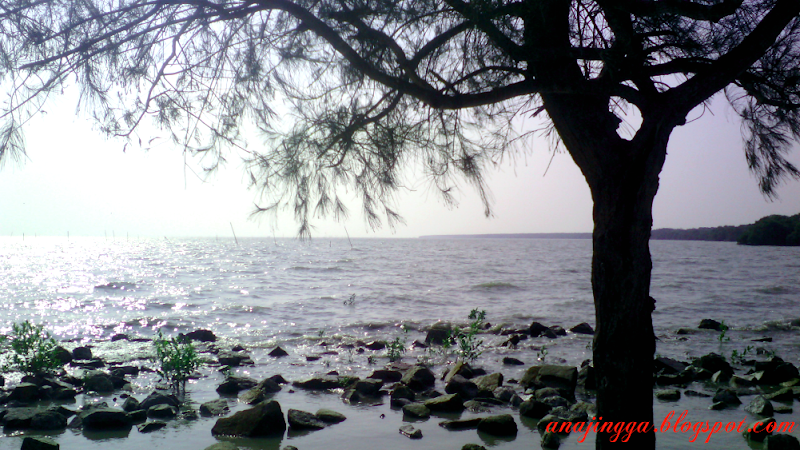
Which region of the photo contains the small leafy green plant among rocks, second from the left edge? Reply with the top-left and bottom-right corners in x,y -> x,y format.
153,330 -> 201,396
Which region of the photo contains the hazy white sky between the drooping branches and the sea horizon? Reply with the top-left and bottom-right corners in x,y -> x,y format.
0,92 -> 800,237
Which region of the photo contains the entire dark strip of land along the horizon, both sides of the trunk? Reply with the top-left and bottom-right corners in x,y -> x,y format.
420,214 -> 800,246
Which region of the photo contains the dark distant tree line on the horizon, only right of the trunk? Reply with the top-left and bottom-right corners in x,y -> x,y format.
651,214 -> 800,246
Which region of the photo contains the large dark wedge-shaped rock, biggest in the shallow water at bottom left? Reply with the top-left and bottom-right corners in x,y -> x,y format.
211,400 -> 286,437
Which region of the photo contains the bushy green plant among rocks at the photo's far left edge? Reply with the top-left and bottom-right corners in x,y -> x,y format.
0,320 -> 61,375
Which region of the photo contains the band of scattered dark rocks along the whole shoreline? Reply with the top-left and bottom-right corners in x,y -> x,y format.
0,320 -> 800,450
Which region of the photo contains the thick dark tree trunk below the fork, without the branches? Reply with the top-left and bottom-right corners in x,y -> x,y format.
592,157 -> 658,450
